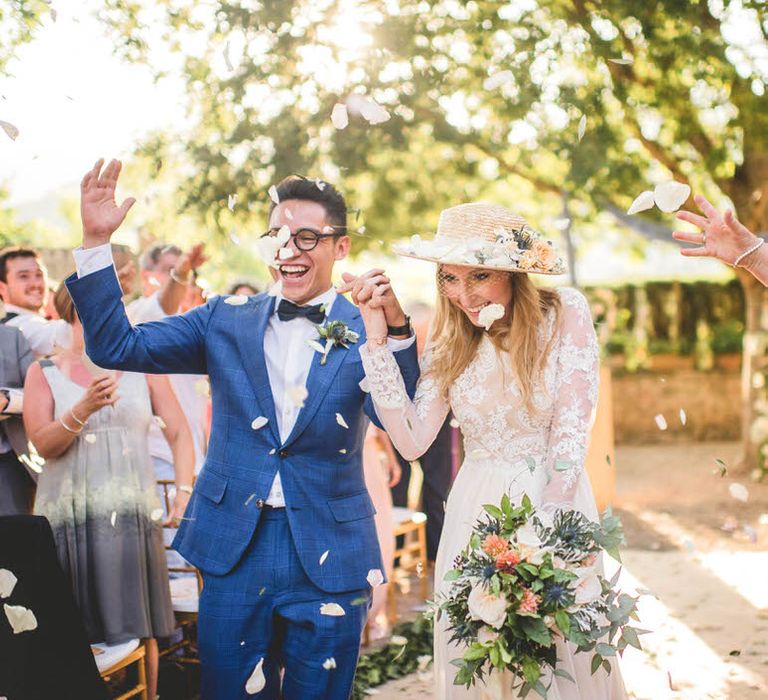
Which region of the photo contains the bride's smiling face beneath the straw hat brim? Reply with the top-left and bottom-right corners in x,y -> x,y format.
437,265 -> 512,327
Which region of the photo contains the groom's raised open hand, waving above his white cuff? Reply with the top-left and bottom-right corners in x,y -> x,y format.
80,158 -> 136,248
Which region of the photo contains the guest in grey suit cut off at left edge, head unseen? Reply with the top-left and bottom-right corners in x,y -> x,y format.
0,325 -> 37,515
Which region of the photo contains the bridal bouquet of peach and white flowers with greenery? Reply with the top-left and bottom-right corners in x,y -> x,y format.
437,495 -> 643,698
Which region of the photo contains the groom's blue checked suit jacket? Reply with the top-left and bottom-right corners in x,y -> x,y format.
67,267 -> 419,593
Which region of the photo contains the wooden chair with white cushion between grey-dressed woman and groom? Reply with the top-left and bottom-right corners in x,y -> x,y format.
157,479 -> 203,664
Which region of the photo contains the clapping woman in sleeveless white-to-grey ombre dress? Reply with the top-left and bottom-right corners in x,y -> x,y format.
24,285 -> 194,698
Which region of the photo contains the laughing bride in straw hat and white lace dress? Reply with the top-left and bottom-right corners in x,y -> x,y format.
349,203 -> 626,700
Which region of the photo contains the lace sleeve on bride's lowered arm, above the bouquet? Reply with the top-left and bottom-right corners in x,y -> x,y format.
544,289 -> 600,507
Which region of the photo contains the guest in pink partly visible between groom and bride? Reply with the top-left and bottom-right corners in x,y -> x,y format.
363,425 -> 400,639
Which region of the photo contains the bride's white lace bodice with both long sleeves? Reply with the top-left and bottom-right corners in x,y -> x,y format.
360,288 -> 599,503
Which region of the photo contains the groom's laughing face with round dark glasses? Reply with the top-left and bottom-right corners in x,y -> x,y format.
269,199 -> 350,304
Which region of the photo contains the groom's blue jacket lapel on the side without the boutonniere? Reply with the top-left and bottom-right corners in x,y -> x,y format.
235,296 -> 280,442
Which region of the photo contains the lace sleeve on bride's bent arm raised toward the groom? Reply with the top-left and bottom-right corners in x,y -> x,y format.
360,344 -> 449,461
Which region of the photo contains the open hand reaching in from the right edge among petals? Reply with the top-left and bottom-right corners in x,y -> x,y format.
672,195 -> 759,265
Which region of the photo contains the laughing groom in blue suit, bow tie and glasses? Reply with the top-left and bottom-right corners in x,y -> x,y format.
67,161 -> 418,700
